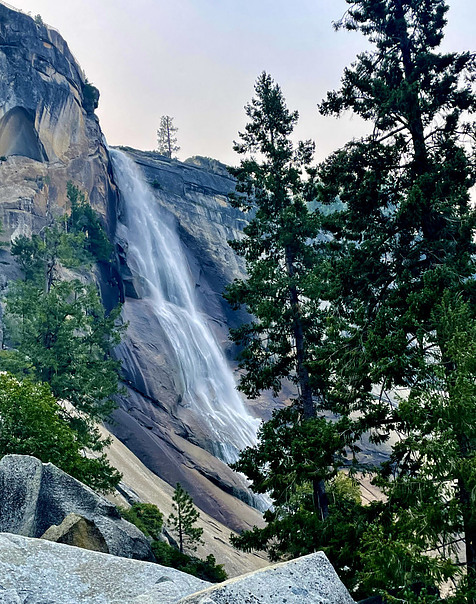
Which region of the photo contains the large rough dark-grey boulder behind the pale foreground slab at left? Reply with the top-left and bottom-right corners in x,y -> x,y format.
0,455 -> 154,561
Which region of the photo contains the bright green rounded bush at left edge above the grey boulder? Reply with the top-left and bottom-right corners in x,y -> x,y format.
0,373 -> 121,491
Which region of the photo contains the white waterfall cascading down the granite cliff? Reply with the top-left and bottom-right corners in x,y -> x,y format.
110,149 -> 259,463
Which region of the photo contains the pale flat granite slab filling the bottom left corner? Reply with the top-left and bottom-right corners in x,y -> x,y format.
0,533 -> 210,604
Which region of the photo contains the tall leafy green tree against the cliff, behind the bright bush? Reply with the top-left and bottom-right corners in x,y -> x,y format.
0,206 -> 123,488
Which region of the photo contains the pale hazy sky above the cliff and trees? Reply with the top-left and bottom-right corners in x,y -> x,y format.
4,0 -> 476,164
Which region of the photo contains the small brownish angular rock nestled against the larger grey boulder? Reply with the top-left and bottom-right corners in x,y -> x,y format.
41,514 -> 109,554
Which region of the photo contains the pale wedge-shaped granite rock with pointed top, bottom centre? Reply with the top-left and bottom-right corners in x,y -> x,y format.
180,552 -> 355,604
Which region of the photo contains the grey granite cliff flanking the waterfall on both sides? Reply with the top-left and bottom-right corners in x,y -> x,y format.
0,3 -> 266,529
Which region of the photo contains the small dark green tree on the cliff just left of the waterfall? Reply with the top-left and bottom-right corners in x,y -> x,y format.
67,182 -> 113,262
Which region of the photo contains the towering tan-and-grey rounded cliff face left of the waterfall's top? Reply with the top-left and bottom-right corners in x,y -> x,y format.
0,4 -> 115,245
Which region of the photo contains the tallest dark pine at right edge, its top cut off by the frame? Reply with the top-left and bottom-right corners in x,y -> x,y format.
319,0 -> 476,598
